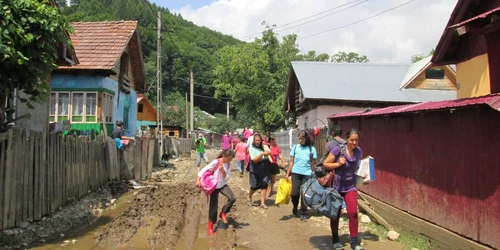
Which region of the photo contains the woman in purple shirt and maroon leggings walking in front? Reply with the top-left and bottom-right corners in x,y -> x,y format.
323,129 -> 363,250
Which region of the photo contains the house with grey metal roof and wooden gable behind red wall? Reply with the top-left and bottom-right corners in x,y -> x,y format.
283,57 -> 456,128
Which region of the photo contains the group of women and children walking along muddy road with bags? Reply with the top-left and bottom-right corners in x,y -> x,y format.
196,127 -> 363,250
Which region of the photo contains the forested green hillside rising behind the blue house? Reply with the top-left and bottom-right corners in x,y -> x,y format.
58,0 -> 240,113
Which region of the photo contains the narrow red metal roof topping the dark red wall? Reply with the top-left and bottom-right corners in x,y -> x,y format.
328,94 -> 500,118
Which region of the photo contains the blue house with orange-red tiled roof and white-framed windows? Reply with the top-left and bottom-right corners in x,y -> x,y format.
49,21 -> 145,136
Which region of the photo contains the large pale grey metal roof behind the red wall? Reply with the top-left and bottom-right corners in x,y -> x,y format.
292,62 -> 456,102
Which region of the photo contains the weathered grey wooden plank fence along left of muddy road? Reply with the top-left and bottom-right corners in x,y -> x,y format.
0,129 -> 158,230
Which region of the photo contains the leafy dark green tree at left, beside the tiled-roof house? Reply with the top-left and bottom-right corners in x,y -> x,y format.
0,0 -> 71,131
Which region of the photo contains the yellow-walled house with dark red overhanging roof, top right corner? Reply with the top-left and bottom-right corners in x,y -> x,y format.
432,0 -> 500,98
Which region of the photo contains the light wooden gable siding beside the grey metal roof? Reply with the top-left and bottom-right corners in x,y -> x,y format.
406,66 -> 457,90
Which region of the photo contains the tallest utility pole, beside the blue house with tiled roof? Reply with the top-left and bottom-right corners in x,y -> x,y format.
156,11 -> 165,157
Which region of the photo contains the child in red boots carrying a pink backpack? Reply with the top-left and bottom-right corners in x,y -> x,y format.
195,149 -> 236,235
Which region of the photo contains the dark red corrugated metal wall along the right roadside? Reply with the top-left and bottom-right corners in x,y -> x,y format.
332,106 -> 500,248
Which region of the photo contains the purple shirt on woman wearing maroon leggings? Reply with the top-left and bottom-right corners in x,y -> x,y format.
330,146 -> 363,193
